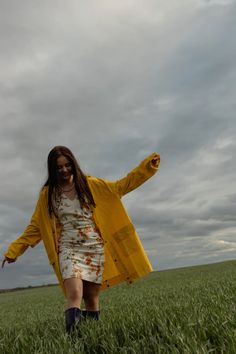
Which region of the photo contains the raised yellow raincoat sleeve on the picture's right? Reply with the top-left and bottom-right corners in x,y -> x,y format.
109,152 -> 160,197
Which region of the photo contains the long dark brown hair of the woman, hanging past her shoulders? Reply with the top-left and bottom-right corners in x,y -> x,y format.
43,145 -> 95,216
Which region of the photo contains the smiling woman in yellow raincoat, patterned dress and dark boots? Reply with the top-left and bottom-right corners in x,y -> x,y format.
2,146 -> 160,333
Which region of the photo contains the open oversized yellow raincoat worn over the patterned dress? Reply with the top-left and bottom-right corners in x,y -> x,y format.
5,153 -> 158,294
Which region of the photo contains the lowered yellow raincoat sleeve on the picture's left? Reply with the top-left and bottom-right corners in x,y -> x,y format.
4,196 -> 41,259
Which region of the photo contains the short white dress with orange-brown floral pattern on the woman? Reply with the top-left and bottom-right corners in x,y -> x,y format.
57,193 -> 104,284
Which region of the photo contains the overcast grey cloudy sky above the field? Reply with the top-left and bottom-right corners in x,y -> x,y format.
0,0 -> 236,288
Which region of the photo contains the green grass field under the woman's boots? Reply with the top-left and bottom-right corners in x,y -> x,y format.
0,261 -> 236,354
